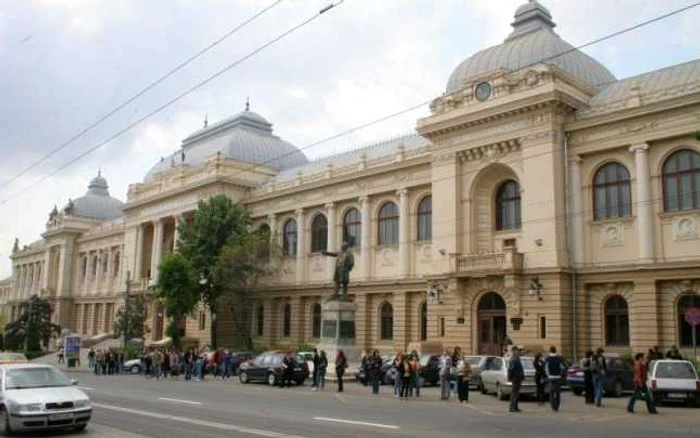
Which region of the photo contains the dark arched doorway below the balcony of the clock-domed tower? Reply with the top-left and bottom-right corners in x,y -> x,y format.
477,292 -> 506,356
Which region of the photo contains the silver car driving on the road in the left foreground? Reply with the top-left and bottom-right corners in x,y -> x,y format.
0,363 -> 92,436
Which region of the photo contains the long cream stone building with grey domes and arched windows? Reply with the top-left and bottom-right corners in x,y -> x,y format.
5,1 -> 700,355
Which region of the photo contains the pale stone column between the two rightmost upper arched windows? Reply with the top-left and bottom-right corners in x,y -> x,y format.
630,143 -> 654,263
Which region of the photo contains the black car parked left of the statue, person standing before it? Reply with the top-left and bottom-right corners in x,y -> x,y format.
238,351 -> 309,386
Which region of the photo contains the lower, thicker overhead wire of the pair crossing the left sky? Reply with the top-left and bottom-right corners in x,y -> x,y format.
0,0 -> 345,205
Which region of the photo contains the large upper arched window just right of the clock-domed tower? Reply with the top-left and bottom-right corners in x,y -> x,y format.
593,163 -> 632,220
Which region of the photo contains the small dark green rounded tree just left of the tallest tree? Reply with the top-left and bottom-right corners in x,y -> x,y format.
156,253 -> 200,349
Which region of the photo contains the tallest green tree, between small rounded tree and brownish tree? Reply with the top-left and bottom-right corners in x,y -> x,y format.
178,195 -> 252,348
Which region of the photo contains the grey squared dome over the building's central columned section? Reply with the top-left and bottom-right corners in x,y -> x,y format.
145,107 -> 309,182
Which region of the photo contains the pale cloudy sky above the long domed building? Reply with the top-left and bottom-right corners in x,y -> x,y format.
0,0 -> 700,277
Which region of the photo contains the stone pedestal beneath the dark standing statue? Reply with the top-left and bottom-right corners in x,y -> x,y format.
318,300 -> 358,362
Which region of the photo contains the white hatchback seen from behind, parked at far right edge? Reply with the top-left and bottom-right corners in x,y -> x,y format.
647,359 -> 700,406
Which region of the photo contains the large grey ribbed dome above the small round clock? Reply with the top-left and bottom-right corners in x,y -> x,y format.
447,0 -> 617,94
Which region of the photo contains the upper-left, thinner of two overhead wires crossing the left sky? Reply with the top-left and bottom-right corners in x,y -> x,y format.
0,0 -> 284,189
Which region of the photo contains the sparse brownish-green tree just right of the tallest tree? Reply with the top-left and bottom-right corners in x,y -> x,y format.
217,226 -> 282,350
